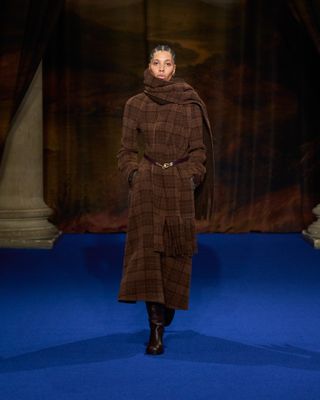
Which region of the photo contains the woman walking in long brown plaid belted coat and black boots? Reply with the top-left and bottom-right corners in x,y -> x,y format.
118,45 -> 212,355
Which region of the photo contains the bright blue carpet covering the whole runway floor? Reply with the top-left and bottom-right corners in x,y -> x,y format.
0,234 -> 320,400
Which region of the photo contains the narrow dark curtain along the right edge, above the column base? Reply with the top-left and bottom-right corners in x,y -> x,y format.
287,0 -> 320,225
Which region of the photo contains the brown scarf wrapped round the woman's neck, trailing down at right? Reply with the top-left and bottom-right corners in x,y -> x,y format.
144,68 -> 214,219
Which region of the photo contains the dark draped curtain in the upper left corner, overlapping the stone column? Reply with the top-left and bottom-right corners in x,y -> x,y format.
0,0 -> 63,159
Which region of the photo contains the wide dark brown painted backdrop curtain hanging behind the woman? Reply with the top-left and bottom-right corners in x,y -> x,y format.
45,0 -> 320,232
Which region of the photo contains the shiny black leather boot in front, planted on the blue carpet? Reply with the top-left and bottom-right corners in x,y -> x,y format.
146,302 -> 165,356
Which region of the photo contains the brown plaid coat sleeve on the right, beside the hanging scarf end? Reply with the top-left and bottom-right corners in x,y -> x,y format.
187,104 -> 206,185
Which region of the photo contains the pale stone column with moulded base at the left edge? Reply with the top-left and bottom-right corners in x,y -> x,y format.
0,63 -> 59,248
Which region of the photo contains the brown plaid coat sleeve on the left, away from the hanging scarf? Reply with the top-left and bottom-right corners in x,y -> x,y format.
117,98 -> 139,182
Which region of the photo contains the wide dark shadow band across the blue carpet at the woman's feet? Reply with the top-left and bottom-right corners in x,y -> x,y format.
0,330 -> 320,373
